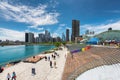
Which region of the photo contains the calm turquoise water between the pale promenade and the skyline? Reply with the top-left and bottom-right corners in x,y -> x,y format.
0,45 -> 54,65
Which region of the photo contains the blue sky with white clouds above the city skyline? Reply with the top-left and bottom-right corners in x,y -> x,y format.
0,0 -> 120,41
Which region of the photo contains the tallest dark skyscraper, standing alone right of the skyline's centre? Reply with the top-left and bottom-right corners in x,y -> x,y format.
71,20 -> 79,41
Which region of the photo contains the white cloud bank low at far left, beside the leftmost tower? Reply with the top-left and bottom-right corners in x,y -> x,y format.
0,28 -> 25,41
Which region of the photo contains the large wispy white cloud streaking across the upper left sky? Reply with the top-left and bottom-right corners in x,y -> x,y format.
0,1 -> 59,28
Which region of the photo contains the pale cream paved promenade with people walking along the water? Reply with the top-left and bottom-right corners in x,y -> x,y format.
0,48 -> 67,80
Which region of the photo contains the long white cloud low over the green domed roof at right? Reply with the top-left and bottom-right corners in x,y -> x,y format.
81,21 -> 120,34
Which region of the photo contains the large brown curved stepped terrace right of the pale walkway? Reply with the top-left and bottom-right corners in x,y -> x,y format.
62,47 -> 120,80
